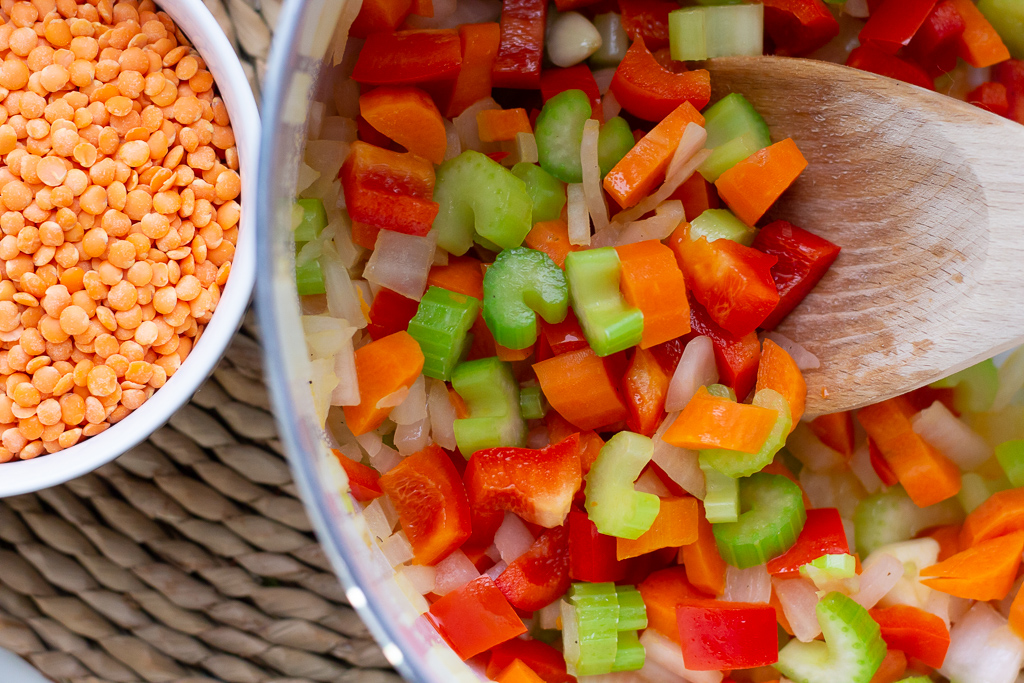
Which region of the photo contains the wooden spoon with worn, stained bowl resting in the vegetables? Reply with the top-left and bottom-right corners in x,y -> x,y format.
708,57 -> 1024,416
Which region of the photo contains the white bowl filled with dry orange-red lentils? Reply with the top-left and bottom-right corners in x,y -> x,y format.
0,0 -> 259,497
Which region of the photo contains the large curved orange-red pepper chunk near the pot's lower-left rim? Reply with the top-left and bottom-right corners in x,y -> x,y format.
380,444 -> 472,564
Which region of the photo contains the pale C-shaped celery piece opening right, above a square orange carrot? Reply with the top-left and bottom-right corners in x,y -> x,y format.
585,431 -> 662,540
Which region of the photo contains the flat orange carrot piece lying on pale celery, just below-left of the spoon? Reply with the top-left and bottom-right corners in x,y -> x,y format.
662,387 -> 778,453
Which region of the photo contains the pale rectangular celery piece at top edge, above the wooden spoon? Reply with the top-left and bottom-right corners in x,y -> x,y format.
669,4 -> 764,61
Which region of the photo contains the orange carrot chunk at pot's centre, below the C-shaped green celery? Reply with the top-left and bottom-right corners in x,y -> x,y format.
534,346 -> 630,429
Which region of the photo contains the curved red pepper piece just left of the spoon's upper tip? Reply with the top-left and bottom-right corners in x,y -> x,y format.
611,37 -> 711,121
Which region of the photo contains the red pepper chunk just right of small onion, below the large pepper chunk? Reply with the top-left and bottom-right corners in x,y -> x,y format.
495,524 -> 569,612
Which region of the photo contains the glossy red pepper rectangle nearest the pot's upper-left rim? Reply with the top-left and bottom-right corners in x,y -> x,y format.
352,29 -> 462,85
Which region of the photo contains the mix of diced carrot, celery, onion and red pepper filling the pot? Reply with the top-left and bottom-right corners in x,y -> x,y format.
294,0 -> 1024,683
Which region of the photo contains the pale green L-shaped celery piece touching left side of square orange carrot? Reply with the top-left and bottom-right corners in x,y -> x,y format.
565,247 -> 643,356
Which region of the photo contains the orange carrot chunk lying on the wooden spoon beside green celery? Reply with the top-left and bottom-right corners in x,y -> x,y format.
715,137 -> 807,227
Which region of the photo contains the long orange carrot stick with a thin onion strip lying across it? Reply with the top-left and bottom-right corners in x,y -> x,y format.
604,102 -> 703,209
